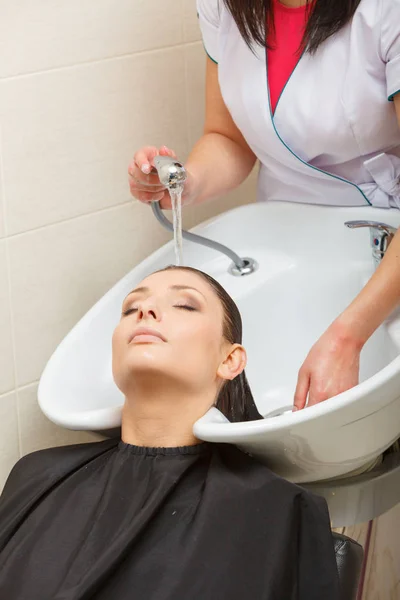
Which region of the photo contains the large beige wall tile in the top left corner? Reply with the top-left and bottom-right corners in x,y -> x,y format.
0,0 -> 187,78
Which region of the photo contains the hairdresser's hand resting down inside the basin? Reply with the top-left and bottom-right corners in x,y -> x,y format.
293,320 -> 362,410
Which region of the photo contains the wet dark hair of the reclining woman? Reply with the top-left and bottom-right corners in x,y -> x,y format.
157,265 -> 262,422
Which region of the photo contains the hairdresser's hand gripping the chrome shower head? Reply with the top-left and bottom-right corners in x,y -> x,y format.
128,146 -> 196,209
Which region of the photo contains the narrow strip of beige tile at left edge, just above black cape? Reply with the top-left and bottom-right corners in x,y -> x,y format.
0,392 -> 19,492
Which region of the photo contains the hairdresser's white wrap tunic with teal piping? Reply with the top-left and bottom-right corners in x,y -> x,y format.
197,0 -> 400,208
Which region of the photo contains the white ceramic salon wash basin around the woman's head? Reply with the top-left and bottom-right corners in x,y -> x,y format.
39,202 -> 400,483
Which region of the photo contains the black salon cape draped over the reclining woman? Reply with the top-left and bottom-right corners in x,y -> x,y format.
0,440 -> 339,600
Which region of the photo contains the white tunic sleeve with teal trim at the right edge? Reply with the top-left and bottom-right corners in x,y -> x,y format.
381,0 -> 400,100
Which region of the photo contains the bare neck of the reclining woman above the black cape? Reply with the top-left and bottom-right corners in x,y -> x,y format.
121,386 -> 214,448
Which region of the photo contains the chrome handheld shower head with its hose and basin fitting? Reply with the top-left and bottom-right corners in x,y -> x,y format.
152,156 -> 258,277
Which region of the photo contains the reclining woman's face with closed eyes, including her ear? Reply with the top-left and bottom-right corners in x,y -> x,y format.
113,270 -> 246,394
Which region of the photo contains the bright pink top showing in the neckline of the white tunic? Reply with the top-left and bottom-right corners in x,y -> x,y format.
267,0 -> 307,113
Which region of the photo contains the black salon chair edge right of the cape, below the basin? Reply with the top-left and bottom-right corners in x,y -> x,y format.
332,533 -> 364,600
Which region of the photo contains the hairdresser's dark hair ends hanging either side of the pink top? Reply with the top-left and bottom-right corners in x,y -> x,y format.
222,0 -> 364,54
